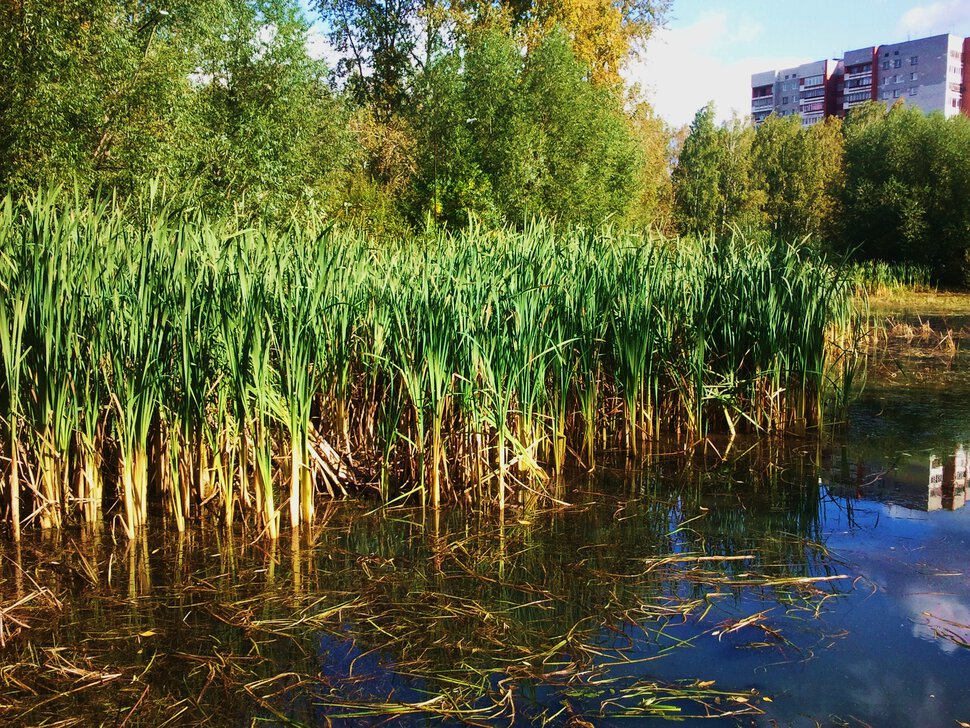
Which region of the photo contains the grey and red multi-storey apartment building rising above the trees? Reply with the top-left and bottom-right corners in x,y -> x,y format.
751,34 -> 970,126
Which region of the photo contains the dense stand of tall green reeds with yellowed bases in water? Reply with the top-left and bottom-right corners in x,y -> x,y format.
0,191 -> 852,538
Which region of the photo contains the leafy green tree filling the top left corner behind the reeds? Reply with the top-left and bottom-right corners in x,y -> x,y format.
0,0 -> 222,191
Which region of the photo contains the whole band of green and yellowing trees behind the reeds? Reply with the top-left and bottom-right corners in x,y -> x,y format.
0,0 -> 970,285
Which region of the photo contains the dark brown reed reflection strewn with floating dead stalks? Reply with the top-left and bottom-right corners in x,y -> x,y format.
0,459 -> 843,725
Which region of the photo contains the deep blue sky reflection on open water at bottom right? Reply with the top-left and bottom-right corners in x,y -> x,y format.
664,490 -> 970,726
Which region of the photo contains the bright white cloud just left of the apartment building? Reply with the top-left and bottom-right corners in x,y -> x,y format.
624,12 -> 812,126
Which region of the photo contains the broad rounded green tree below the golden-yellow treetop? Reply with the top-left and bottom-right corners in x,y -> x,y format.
412,29 -> 642,224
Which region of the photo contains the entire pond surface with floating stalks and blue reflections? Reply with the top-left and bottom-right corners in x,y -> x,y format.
0,306 -> 970,726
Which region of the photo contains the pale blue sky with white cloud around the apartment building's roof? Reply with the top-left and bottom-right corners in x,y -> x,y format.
625,0 -> 970,126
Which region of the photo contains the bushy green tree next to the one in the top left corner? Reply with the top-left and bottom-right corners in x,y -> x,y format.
182,0 -> 352,219
